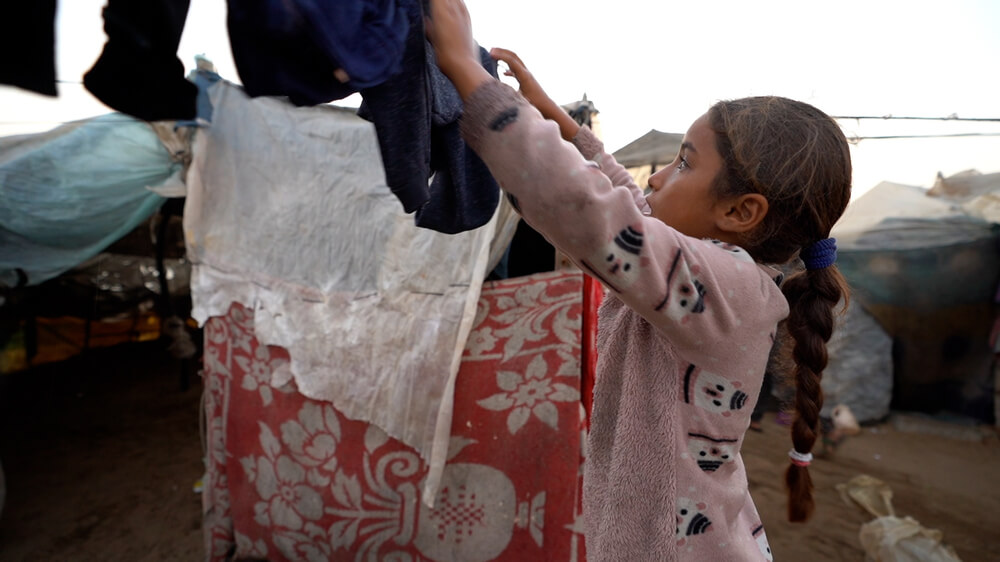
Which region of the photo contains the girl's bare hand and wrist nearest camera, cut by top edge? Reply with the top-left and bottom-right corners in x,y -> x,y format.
424,0 -> 493,99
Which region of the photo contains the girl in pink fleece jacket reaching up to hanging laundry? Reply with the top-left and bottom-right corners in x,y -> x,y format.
427,0 -> 851,561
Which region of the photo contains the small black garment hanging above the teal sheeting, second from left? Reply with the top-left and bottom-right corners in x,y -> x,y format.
83,0 -> 198,121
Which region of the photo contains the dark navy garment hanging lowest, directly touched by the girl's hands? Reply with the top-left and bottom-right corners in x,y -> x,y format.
358,2 -> 500,234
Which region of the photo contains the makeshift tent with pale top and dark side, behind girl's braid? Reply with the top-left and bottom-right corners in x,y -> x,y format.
824,168 -> 1000,421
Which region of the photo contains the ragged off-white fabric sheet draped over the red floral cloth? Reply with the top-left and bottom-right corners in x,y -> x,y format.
184,82 -> 495,499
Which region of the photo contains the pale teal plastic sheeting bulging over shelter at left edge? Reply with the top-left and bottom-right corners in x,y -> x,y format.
0,114 -> 181,286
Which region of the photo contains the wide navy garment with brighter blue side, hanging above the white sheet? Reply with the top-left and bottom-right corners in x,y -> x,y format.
227,0 -> 414,105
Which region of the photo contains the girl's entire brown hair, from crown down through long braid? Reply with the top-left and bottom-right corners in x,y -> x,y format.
708,96 -> 851,521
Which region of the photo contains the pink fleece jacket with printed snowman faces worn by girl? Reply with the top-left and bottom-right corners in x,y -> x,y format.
461,82 -> 788,562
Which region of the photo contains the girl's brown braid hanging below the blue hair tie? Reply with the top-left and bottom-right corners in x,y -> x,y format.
782,266 -> 847,522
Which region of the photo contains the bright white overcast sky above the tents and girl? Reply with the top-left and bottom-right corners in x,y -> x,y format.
0,0 -> 1000,198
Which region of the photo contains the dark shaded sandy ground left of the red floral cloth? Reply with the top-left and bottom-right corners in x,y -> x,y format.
0,342 -> 203,562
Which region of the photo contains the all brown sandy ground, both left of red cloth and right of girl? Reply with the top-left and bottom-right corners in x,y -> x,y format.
0,342 -> 1000,562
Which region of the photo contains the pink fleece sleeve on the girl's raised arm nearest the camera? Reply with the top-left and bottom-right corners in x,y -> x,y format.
461,82 -> 787,362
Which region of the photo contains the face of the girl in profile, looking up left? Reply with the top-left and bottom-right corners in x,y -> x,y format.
646,113 -> 728,237
